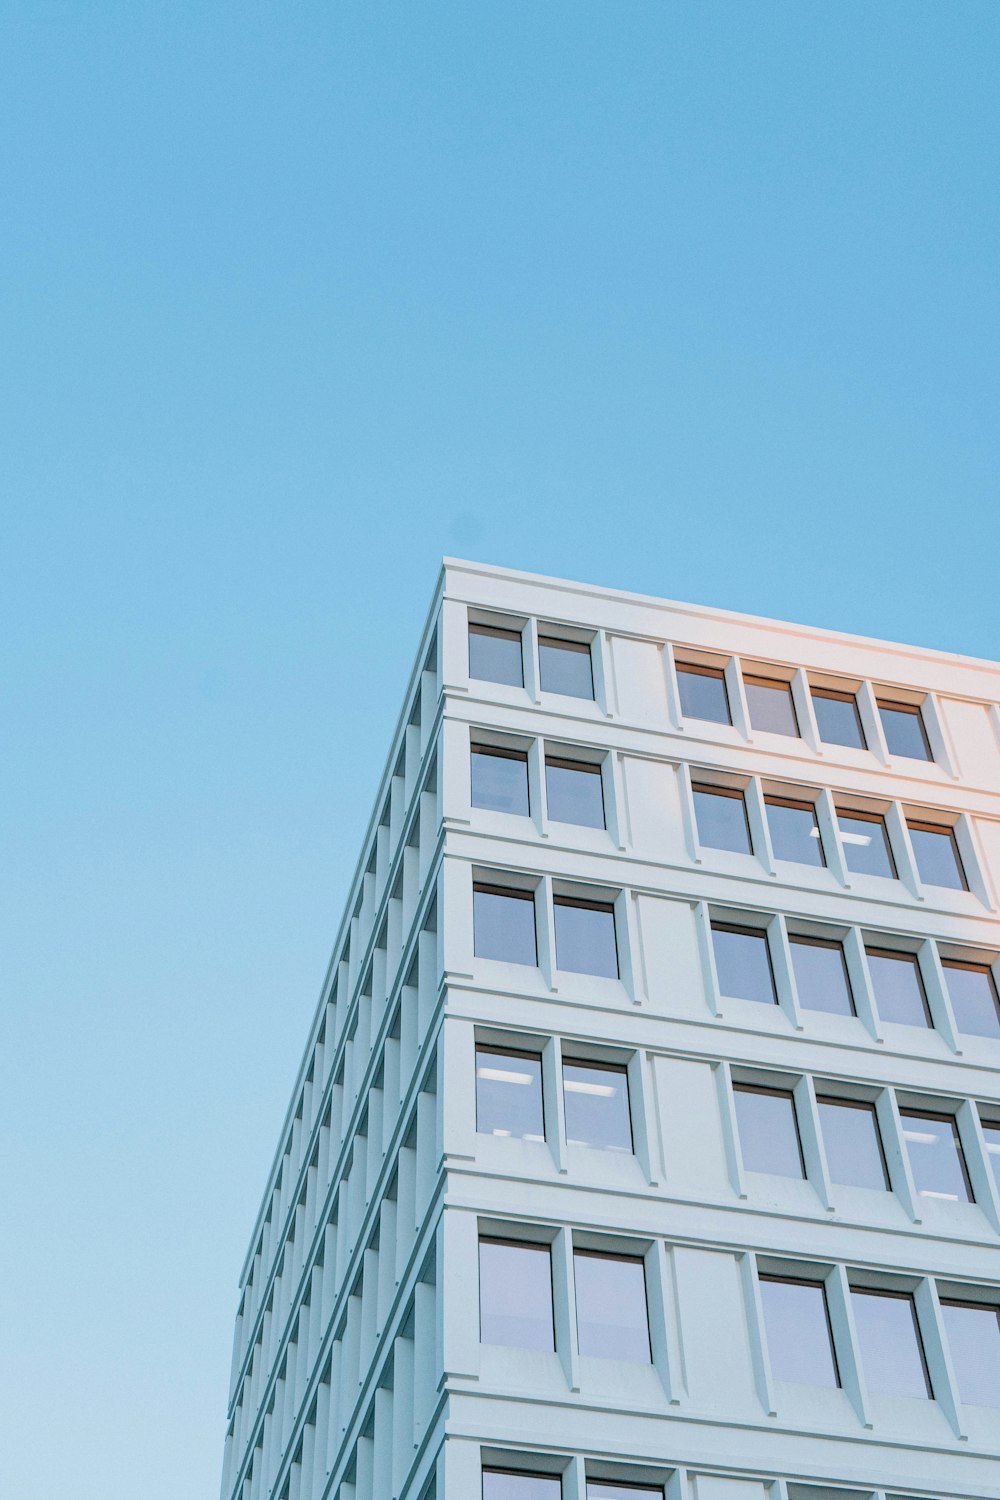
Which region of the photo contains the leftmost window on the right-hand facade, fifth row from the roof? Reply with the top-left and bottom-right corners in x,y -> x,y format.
480,1238 -> 556,1349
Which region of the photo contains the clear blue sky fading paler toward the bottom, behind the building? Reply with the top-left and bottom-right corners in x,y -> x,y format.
0,0 -> 1000,1500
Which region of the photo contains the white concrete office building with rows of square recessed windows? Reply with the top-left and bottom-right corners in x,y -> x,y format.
222,561 -> 1000,1500
